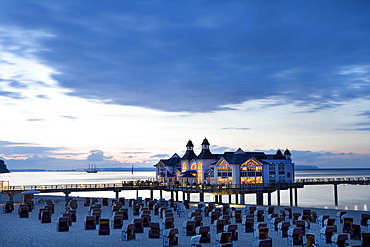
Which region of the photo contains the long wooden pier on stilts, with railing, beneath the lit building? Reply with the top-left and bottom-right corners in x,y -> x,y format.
1,177 -> 370,206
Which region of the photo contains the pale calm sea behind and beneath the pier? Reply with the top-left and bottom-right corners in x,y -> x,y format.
0,169 -> 370,211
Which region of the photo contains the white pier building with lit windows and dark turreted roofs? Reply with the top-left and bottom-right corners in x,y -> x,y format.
154,139 -> 294,185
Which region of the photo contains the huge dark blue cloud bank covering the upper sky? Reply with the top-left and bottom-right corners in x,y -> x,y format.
0,0 -> 370,112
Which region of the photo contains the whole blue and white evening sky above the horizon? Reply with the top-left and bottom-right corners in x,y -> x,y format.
0,0 -> 370,170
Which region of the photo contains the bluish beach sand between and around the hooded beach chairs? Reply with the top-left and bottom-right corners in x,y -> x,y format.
0,195 -> 369,247
